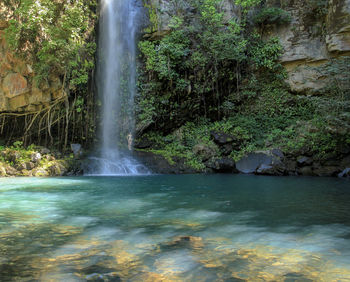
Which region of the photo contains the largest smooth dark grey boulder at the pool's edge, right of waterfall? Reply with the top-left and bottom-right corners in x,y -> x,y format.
236,150 -> 285,175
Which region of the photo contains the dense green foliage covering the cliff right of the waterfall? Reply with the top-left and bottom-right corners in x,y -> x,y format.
137,0 -> 350,171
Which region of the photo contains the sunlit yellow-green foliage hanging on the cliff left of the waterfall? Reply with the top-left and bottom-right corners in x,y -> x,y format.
6,0 -> 96,88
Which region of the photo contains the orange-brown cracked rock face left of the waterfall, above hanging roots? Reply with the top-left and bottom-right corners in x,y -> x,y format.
0,20 -> 64,112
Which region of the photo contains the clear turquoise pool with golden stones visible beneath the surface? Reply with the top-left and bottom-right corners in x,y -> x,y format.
0,175 -> 350,282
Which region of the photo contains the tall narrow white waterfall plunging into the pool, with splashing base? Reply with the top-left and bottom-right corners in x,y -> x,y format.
90,0 -> 147,175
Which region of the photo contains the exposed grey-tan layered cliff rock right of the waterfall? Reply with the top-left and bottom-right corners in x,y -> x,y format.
146,0 -> 350,94
